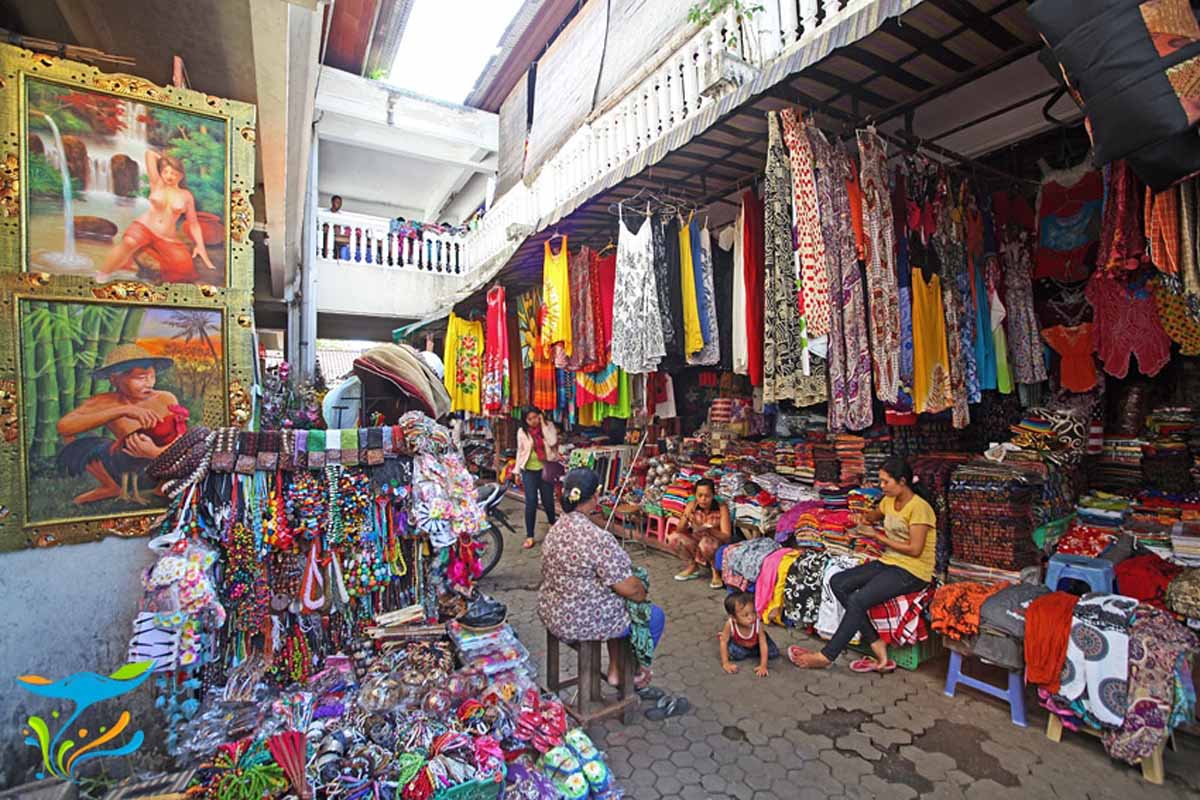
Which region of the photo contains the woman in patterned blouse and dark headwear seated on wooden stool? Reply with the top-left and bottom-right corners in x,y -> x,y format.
538,469 -> 666,688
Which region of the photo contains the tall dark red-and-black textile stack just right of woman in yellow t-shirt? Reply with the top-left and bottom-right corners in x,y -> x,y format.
950,459 -> 1043,571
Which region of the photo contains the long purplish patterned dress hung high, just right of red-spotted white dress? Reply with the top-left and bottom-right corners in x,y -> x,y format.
806,126 -> 872,431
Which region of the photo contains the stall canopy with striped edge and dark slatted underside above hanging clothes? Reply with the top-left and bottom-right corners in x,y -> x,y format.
451,0 -> 1082,307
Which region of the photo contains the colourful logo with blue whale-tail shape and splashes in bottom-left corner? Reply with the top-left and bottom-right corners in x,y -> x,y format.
17,661 -> 154,782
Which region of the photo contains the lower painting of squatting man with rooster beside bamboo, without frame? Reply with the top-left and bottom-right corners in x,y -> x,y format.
19,299 -> 227,524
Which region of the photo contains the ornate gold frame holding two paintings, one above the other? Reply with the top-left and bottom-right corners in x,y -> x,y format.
0,38 -> 256,551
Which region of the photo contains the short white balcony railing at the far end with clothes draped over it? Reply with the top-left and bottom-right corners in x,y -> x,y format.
314,209 -> 472,275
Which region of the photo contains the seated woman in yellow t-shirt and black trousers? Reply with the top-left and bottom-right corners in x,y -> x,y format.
787,456 -> 937,673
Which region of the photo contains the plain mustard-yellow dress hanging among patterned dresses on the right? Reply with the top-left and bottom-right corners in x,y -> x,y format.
912,272 -> 954,414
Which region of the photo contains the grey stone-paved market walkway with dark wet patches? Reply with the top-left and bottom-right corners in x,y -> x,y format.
482,500 -> 1200,800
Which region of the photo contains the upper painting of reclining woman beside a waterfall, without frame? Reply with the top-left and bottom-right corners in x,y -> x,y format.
24,78 -> 228,285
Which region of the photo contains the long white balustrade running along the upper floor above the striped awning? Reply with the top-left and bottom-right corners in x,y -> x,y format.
453,0 -> 876,275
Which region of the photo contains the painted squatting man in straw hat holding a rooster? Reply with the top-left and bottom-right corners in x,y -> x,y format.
58,344 -> 187,505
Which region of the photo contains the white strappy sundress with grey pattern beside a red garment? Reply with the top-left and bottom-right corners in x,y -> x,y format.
612,209 -> 666,374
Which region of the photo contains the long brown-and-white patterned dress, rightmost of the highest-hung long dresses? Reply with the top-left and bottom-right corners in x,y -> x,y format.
858,128 -> 900,403
